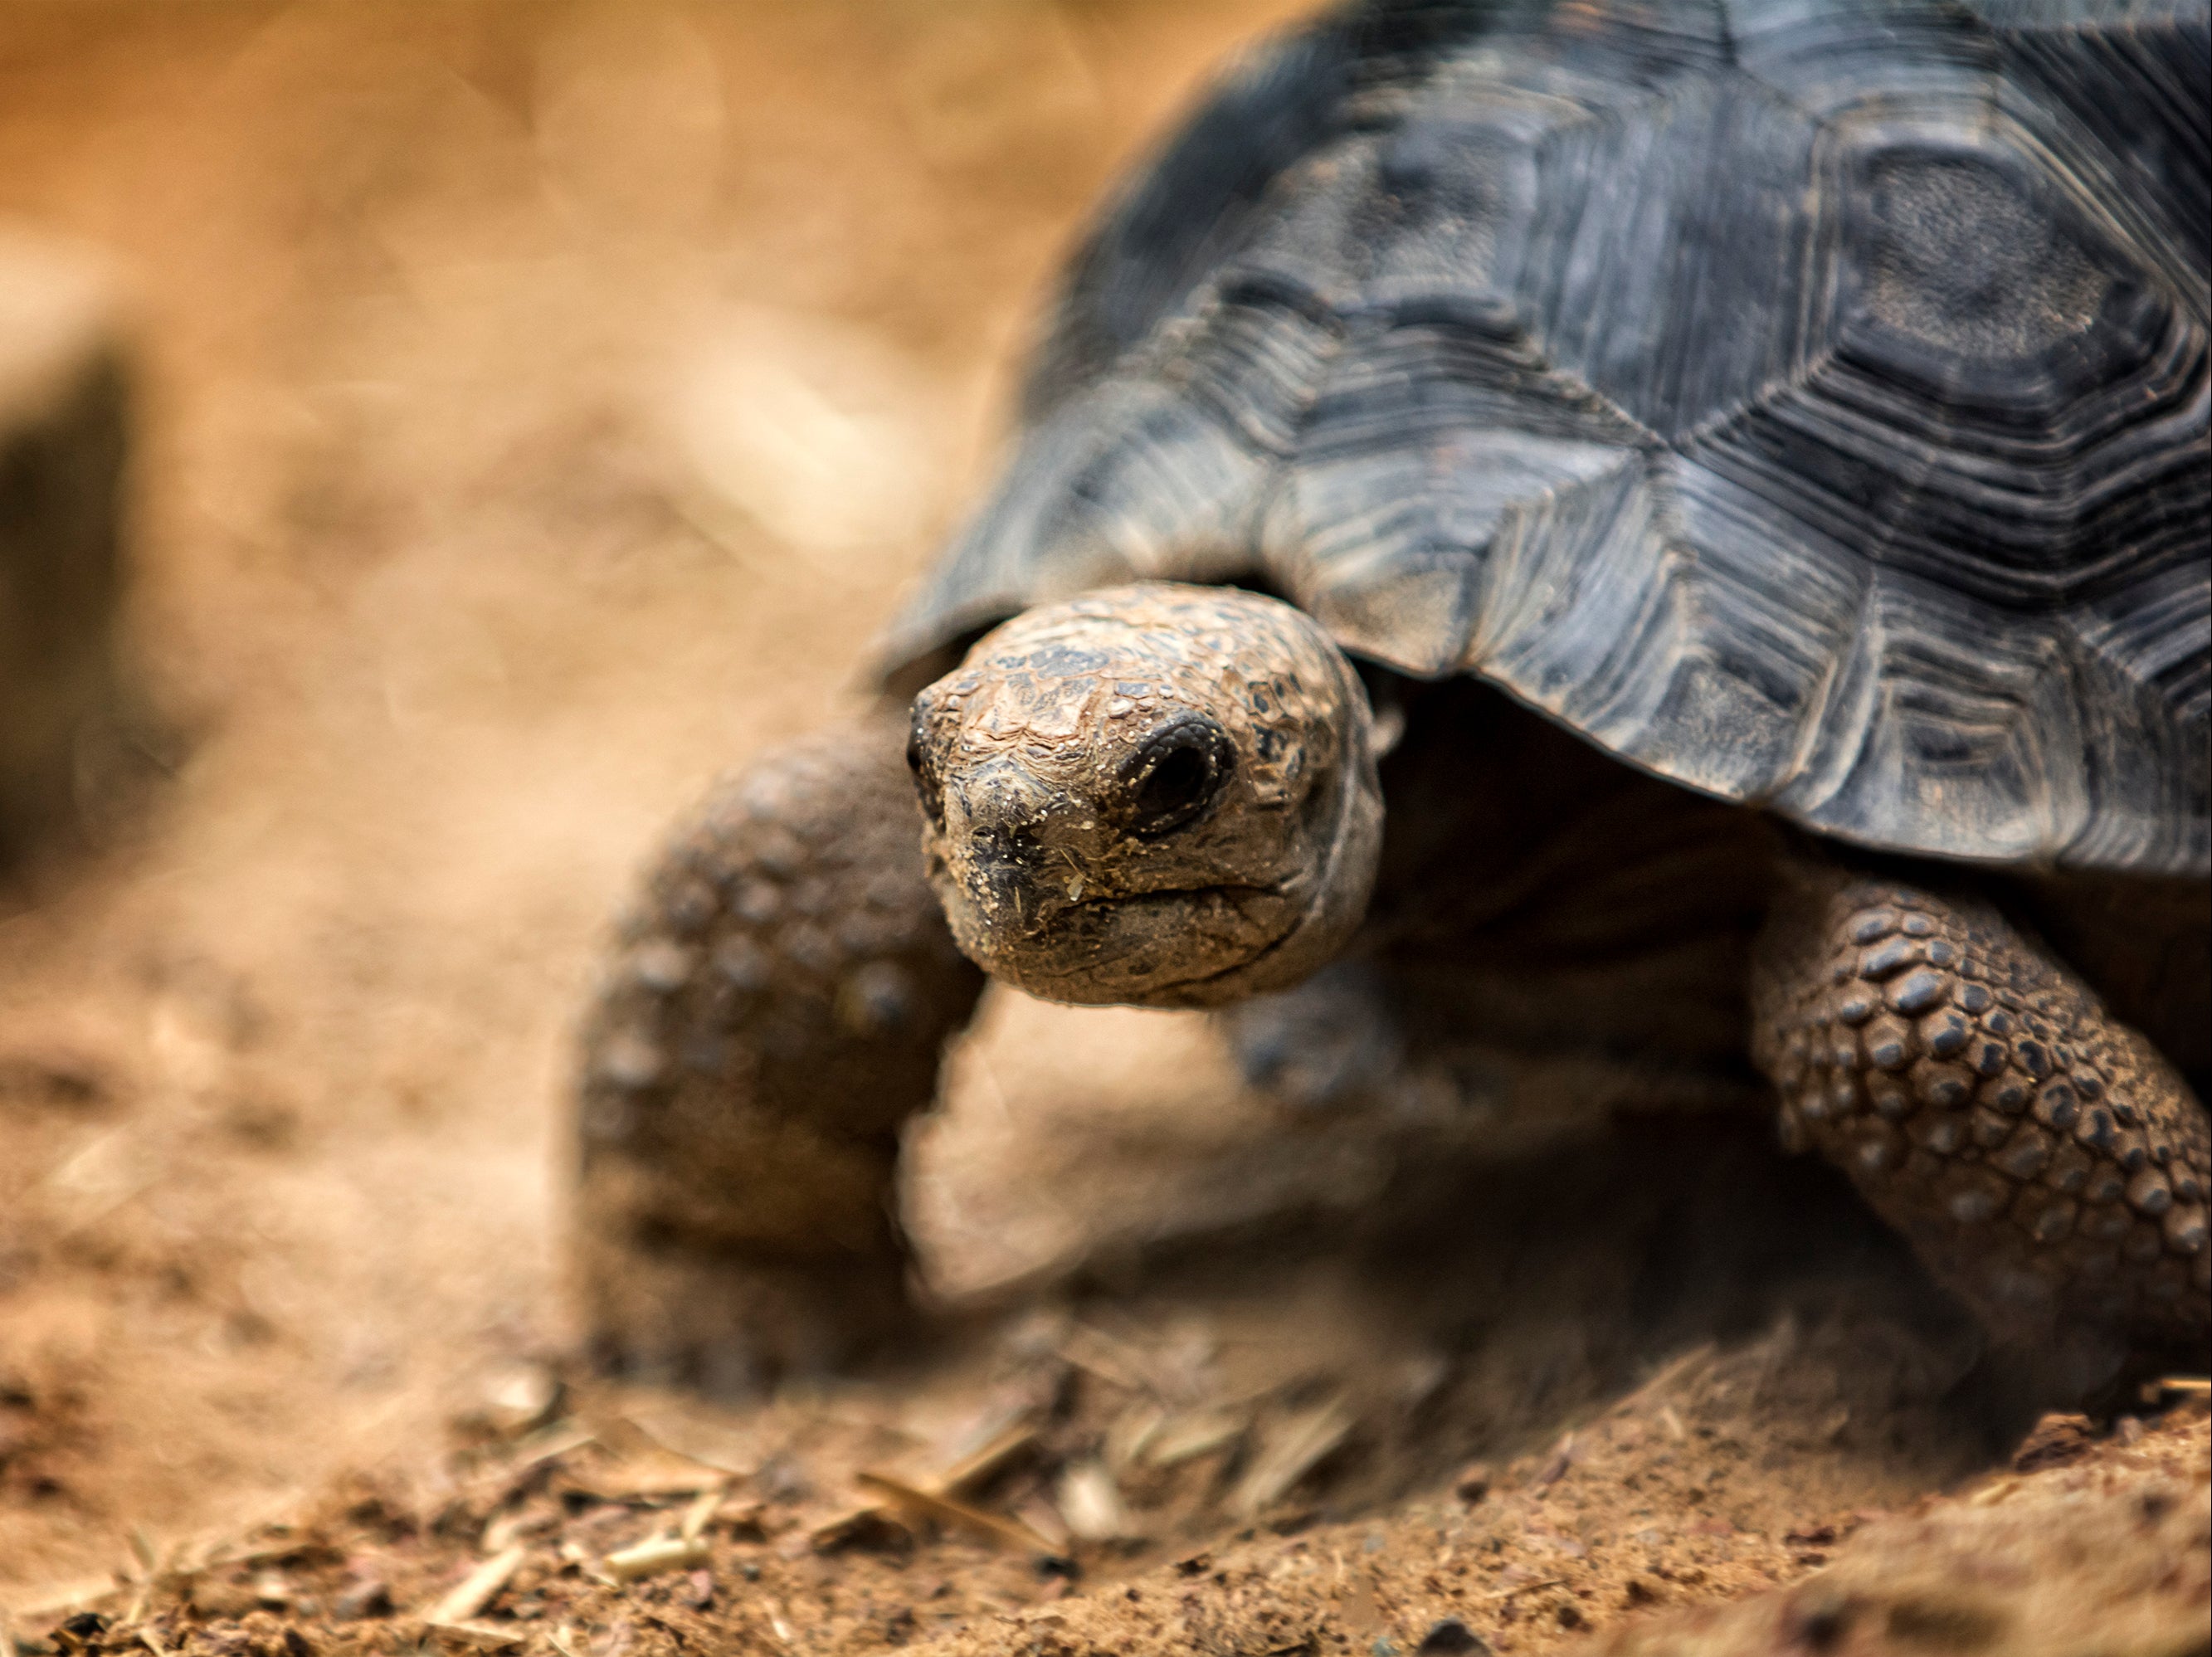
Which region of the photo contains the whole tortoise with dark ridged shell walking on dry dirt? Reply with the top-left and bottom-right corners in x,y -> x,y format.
575,0 -> 2212,1394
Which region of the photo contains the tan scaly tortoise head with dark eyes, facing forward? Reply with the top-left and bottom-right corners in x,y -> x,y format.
909,582 -> 1382,1006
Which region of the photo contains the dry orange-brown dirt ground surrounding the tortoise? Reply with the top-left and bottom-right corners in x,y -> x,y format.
0,0 -> 2212,1657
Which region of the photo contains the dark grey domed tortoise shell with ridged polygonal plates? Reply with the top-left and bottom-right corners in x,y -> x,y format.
889,0 -> 2212,874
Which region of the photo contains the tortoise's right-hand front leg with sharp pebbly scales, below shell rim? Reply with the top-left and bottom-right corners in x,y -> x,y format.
1752,863 -> 2212,1389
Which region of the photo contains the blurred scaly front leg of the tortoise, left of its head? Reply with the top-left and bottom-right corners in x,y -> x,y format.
575,714 -> 982,1391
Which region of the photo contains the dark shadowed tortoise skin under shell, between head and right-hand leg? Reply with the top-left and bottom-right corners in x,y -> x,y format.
1361,680 -> 1771,1070
